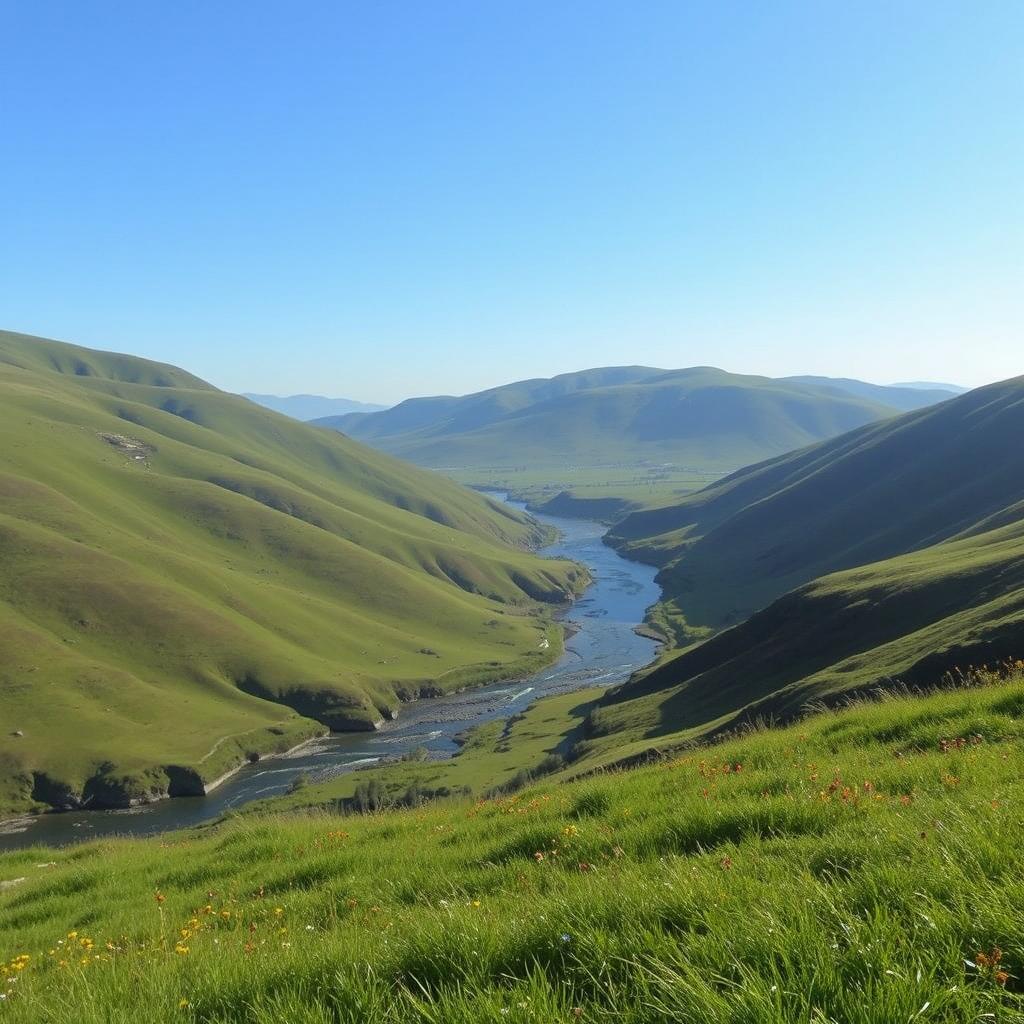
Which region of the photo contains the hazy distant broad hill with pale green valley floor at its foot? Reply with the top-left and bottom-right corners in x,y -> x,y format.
316,367 -> 930,505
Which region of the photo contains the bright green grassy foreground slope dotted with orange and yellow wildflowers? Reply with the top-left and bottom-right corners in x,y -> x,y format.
0,671 -> 1024,1024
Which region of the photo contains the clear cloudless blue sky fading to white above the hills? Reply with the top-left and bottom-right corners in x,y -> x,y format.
0,0 -> 1024,401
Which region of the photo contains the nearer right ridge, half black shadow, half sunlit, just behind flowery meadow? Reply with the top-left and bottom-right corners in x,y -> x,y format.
588,520 -> 1024,748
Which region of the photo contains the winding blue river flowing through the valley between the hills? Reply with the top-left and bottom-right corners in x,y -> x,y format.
0,495 -> 660,850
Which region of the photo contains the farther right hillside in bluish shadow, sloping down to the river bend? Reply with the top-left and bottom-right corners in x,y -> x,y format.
609,378 -> 1024,637
